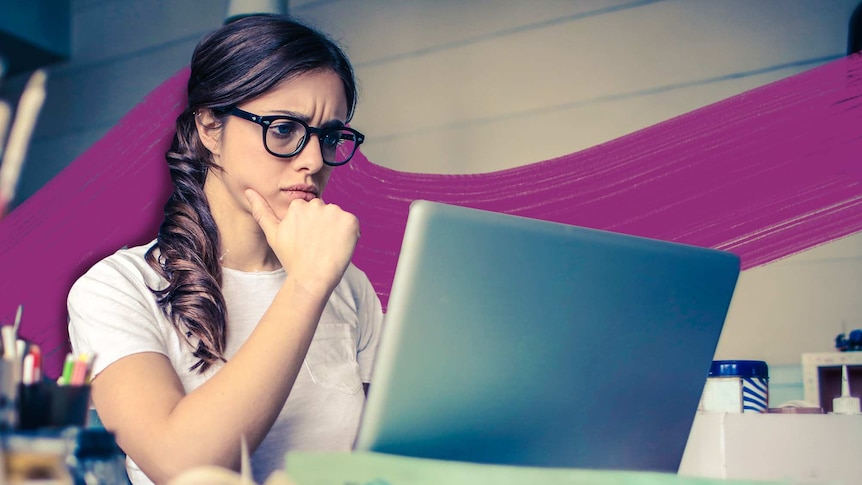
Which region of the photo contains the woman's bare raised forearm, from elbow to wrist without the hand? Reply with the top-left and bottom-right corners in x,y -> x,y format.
100,277 -> 329,481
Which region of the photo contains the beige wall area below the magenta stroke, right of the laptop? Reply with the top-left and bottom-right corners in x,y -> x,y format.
716,234 -> 862,364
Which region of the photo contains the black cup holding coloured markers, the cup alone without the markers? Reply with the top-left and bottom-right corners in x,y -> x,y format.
18,380 -> 90,430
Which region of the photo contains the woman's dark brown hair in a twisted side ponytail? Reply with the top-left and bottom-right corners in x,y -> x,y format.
146,14 -> 357,372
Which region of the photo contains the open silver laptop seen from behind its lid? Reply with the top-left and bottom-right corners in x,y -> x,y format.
356,201 -> 739,472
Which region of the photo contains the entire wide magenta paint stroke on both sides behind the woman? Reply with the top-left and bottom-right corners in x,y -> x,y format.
0,56 -> 862,376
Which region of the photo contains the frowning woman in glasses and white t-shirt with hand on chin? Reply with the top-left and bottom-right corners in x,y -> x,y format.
68,15 -> 382,483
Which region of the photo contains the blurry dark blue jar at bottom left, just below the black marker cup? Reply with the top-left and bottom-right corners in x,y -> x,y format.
72,428 -> 129,485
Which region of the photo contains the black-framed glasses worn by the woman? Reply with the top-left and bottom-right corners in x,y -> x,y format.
221,106 -> 365,167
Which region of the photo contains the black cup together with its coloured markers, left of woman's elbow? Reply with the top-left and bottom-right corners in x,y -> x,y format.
18,354 -> 92,430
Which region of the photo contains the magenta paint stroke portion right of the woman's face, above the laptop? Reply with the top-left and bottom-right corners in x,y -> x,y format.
326,56 -> 862,304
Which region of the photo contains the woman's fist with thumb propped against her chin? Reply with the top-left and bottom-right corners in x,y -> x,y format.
245,189 -> 359,294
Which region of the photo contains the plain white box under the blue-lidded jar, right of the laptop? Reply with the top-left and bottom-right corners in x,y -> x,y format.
679,413 -> 862,485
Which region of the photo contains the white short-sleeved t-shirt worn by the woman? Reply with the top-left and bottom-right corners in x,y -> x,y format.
68,240 -> 383,484
